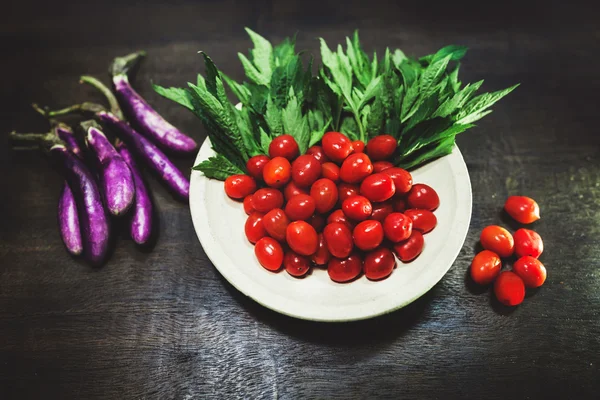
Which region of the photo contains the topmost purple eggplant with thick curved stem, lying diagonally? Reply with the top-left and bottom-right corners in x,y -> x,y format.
110,52 -> 198,154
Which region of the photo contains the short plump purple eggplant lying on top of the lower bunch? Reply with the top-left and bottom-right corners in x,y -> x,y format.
82,121 -> 135,216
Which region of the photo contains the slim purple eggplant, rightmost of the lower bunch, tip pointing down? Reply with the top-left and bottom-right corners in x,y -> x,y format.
117,142 -> 152,245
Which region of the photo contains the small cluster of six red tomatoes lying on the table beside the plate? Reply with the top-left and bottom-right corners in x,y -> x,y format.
471,196 -> 547,306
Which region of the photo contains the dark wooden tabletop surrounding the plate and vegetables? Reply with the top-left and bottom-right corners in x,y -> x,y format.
0,0 -> 600,400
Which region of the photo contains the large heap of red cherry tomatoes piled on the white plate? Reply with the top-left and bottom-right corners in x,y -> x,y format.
225,132 -> 440,283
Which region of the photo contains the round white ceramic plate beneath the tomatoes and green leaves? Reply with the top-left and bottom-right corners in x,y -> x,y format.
190,139 -> 472,322
